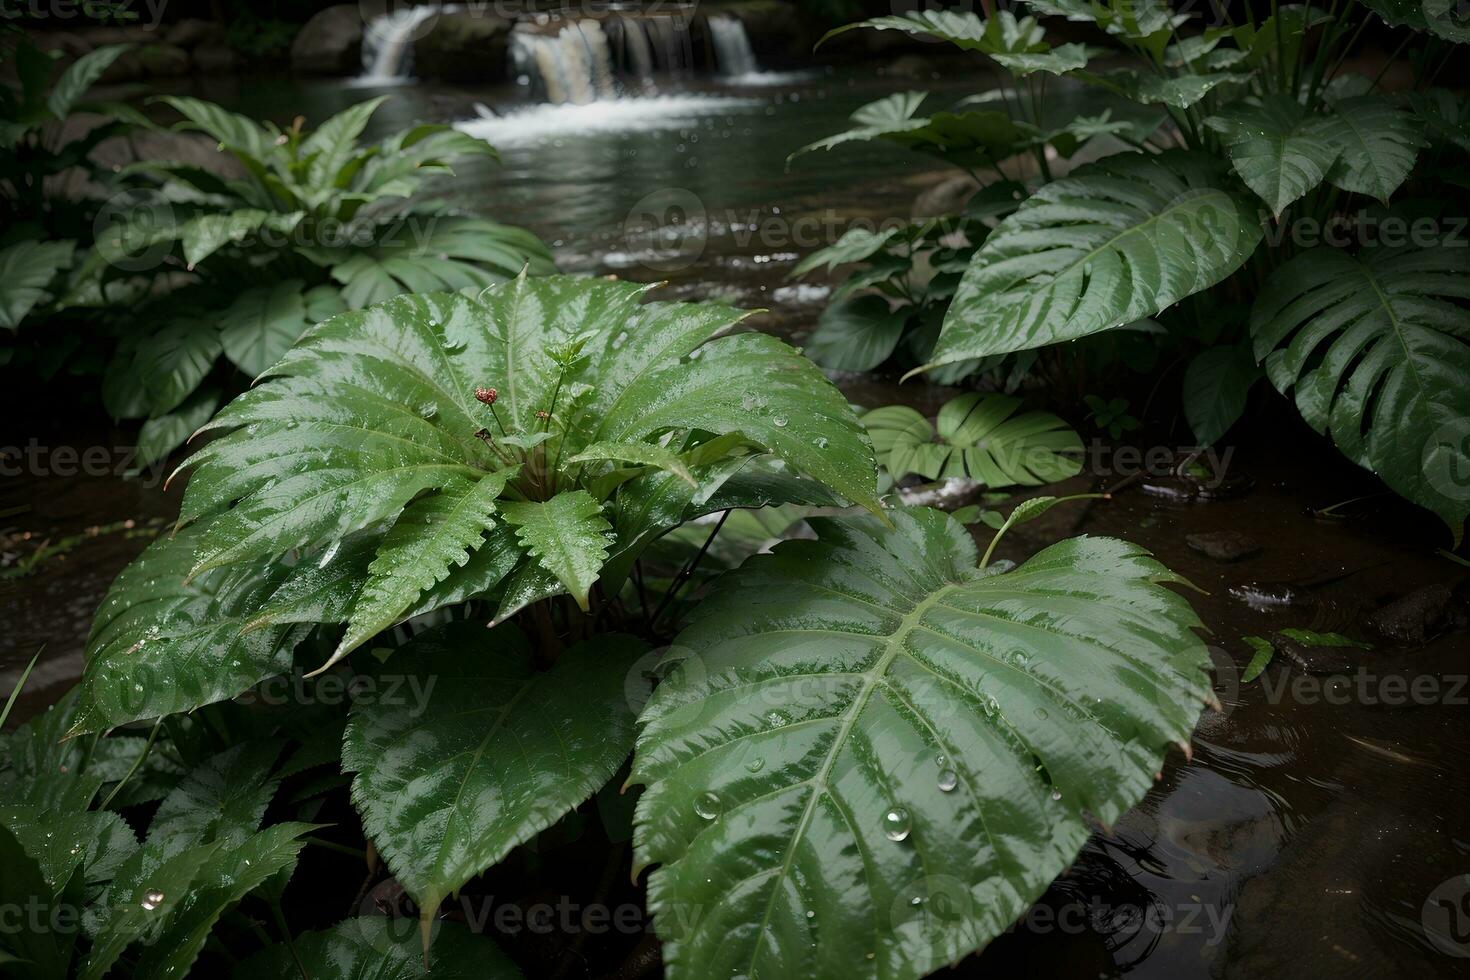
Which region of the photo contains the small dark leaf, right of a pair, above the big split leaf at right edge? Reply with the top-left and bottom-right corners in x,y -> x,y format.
1320,96 -> 1424,201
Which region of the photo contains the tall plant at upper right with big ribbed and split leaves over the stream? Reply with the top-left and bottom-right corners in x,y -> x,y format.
817,0 -> 1470,541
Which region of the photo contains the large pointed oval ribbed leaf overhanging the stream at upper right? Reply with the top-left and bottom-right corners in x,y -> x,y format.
928,151 -> 1261,367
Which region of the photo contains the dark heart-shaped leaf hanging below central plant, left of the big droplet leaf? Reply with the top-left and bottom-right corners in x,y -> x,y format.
343,621 -> 645,917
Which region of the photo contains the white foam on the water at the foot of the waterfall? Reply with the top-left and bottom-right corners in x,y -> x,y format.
454,96 -> 763,144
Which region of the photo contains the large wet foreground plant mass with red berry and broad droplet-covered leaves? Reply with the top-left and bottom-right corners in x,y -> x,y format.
0,275 -> 1210,977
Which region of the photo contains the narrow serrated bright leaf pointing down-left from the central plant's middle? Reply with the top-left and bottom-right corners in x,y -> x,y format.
336,467 -> 519,669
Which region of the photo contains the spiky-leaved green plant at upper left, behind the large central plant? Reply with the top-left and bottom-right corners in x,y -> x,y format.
71,97 -> 551,464
